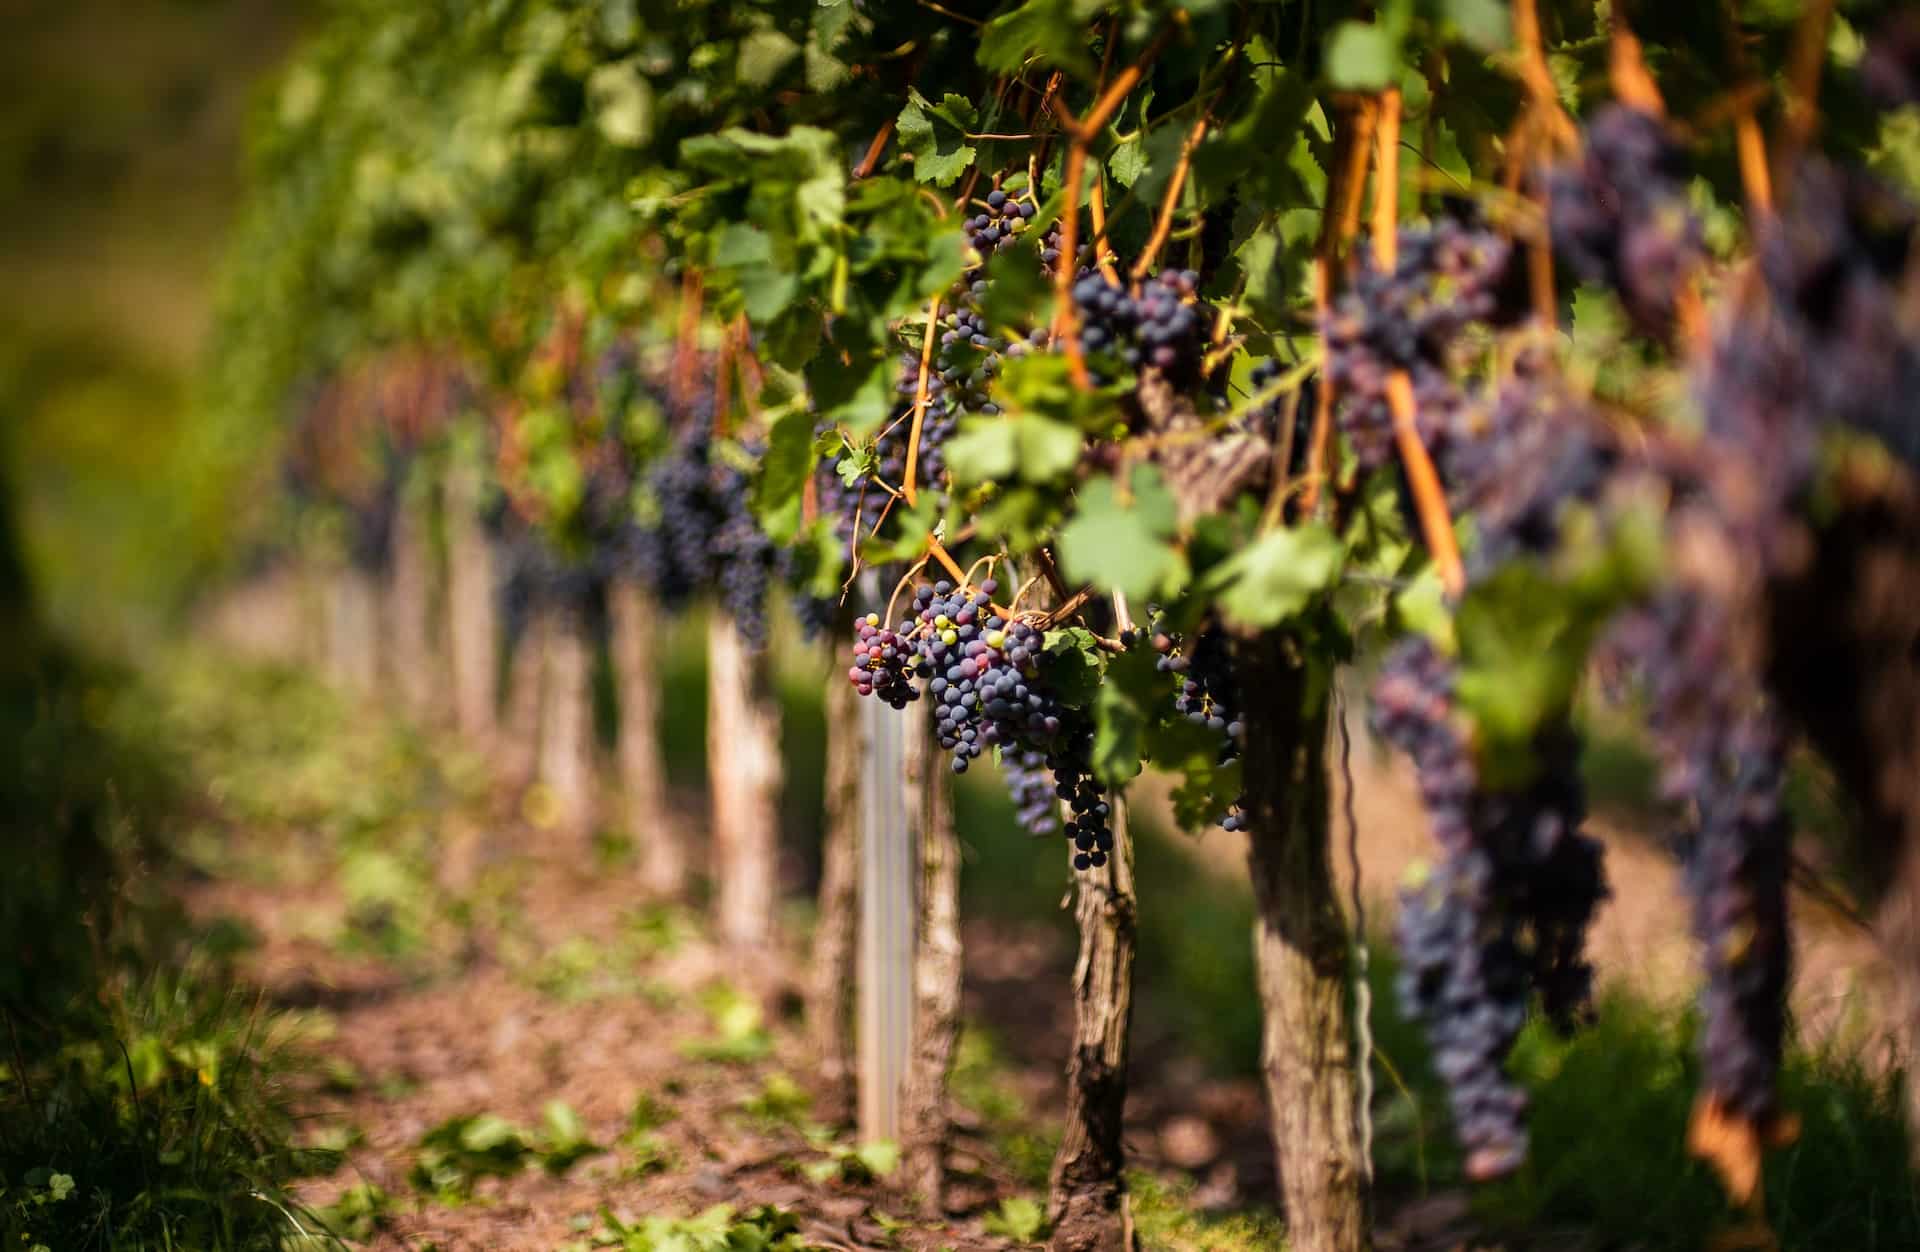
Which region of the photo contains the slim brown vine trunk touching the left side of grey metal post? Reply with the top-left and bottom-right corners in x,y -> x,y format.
806,630 -> 866,1120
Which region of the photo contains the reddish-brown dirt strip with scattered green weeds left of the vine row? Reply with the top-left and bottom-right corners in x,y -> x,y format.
190,831 -> 1016,1252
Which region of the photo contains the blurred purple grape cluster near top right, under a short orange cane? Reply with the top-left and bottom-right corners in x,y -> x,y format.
1548,104 -> 1703,336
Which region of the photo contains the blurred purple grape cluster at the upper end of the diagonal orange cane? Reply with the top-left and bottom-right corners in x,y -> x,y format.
1325,217 -> 1524,472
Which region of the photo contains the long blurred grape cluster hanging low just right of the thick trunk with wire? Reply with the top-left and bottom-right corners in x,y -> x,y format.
1373,638 -> 1607,1179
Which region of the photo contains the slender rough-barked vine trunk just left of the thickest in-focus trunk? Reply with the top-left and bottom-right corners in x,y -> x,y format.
1046,791 -> 1139,1252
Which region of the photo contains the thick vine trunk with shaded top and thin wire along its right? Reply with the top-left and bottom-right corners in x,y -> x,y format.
1238,634 -> 1369,1252
